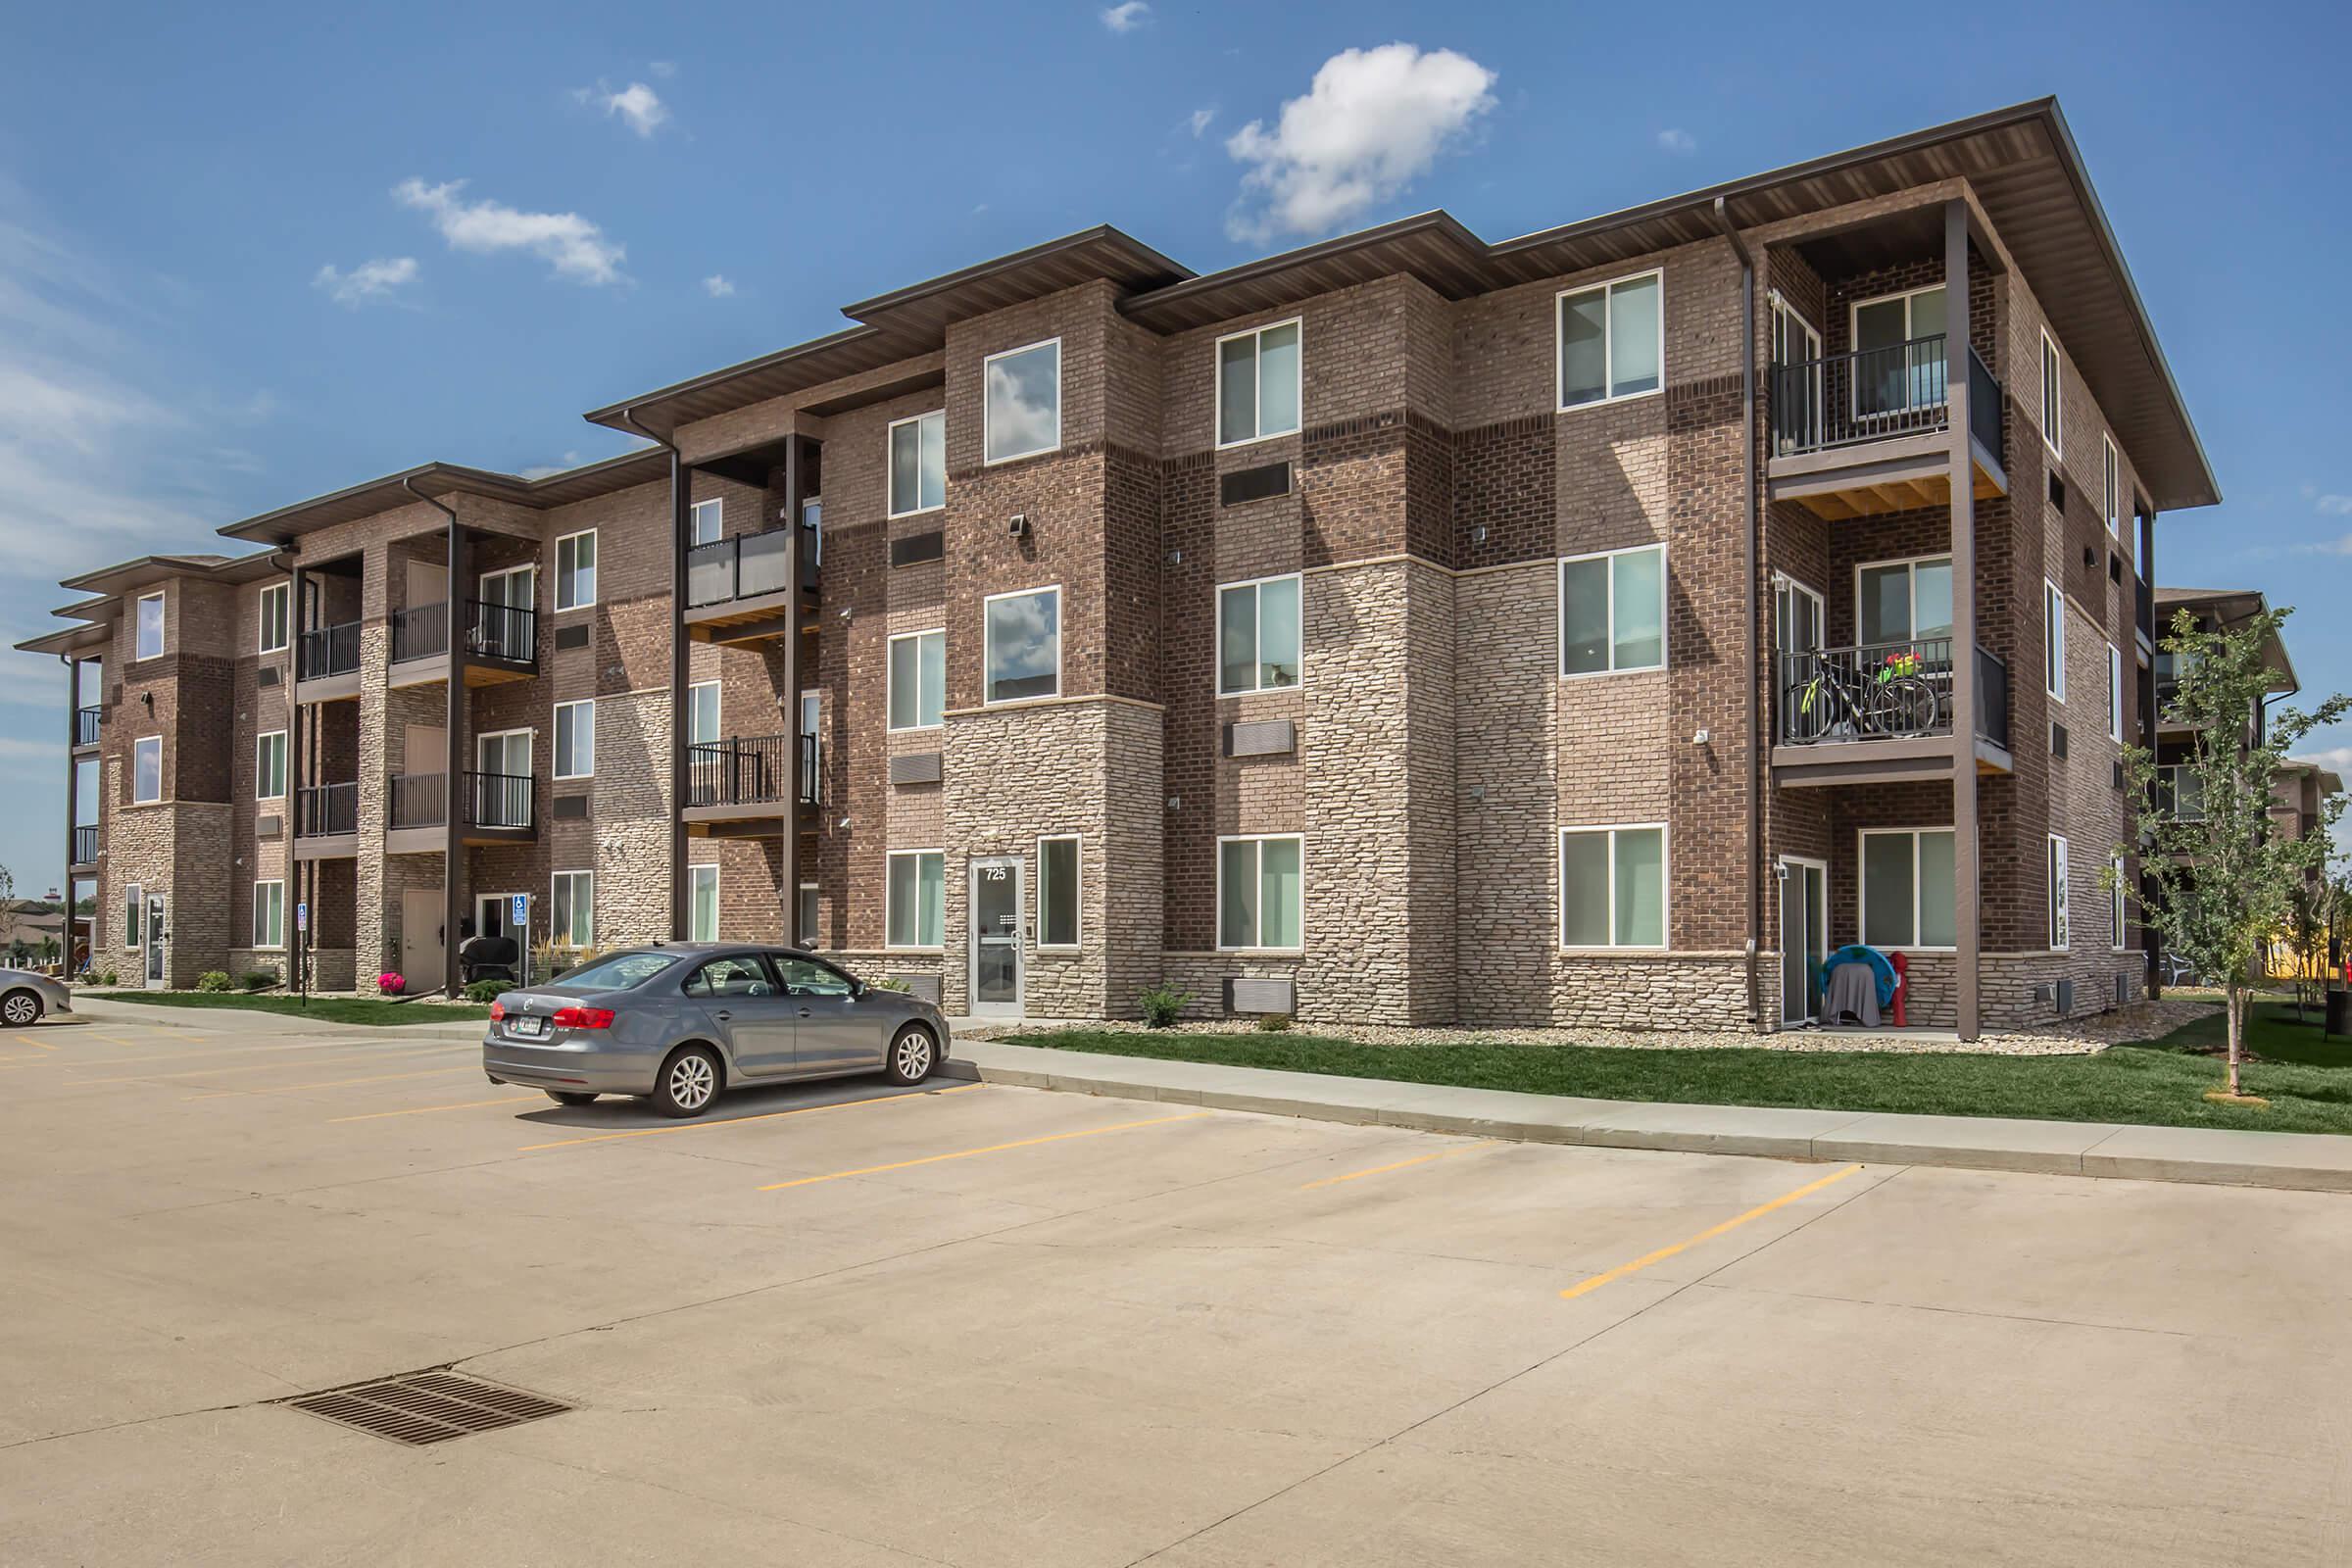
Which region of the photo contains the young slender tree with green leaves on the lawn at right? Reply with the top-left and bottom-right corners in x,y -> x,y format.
2107,609 -> 2352,1096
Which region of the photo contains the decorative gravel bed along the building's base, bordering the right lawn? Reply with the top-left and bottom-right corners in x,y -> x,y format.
957,997 -> 2221,1055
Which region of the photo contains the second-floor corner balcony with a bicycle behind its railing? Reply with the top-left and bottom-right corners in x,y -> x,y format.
1774,637 -> 2011,785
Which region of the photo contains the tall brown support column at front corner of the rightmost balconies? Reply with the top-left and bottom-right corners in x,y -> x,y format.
1942,200 -> 1984,1039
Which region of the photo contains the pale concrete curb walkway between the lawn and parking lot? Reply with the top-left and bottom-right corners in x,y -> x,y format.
941,1039 -> 2352,1192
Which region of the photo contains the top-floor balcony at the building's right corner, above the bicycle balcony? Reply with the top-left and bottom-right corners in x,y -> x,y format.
1766,334 -> 2009,522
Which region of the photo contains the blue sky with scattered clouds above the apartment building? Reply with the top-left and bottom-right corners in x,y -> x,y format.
0,0 -> 2352,894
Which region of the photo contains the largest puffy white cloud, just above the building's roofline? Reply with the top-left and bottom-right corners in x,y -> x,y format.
1225,42 -> 1495,242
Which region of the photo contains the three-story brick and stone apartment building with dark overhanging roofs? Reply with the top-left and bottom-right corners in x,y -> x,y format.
22,101 -> 2218,1037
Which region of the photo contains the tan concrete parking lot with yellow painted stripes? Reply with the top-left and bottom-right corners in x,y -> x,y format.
0,1010 -> 2352,1568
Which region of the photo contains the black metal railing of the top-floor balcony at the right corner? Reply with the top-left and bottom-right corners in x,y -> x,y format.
1771,331 -> 2001,459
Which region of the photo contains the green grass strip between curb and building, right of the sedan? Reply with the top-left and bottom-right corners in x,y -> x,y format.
1018,1002 -> 2352,1133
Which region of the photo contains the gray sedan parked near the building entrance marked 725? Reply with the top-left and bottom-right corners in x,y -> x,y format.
482,943 -> 948,1116
